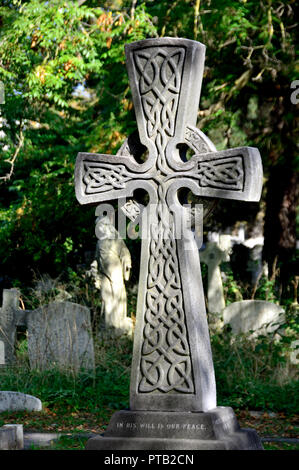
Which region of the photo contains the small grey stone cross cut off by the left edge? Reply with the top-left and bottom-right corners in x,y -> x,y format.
0,289 -> 20,364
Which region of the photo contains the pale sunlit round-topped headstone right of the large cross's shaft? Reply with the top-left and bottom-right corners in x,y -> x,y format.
222,300 -> 285,337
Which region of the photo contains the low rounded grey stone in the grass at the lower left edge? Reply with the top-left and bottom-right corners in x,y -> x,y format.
0,391 -> 42,412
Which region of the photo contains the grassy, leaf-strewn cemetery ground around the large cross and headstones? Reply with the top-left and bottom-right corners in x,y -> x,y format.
0,272 -> 299,450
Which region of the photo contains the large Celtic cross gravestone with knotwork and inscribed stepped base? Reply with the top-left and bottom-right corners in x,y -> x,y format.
75,38 -> 262,450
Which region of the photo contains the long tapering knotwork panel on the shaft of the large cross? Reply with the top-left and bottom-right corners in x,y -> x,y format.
139,187 -> 194,393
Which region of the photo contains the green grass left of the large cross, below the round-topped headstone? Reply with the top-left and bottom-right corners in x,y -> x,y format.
0,338 -> 132,414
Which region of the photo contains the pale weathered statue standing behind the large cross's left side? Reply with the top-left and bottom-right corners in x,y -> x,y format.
91,210 -> 133,336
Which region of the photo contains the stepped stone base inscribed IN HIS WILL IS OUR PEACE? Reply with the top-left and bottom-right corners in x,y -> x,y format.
86,407 -> 263,450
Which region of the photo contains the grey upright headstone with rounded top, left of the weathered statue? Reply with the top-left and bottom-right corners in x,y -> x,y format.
27,302 -> 94,372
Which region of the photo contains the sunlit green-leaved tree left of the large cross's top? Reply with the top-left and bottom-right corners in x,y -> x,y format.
0,0 -> 156,279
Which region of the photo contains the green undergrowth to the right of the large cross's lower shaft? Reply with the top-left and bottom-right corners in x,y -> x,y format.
211,330 -> 299,413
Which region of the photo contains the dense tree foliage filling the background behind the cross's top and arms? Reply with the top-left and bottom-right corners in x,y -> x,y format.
0,0 -> 298,279
